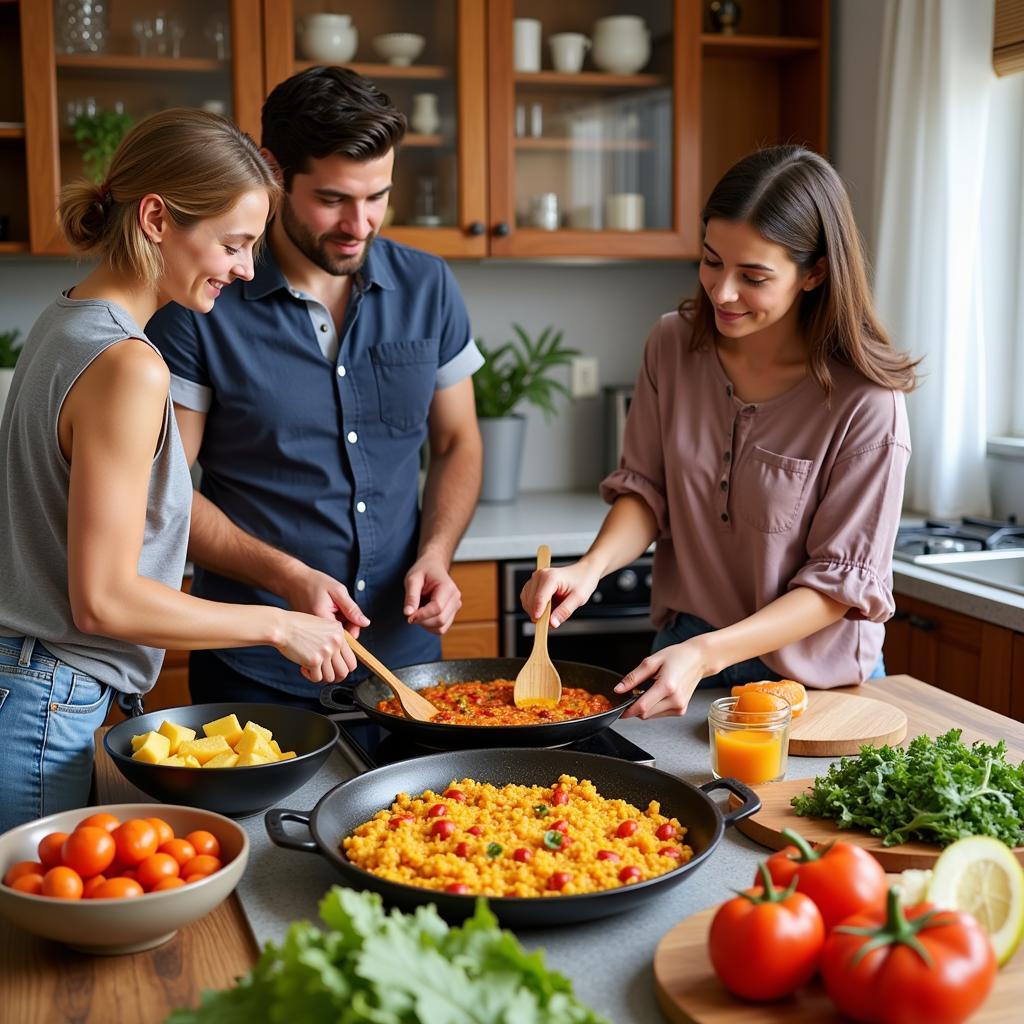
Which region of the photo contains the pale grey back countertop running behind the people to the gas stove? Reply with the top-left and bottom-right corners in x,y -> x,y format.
455,490 -> 1024,632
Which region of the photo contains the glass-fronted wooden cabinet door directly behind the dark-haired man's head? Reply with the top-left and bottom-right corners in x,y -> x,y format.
264,0 -> 487,256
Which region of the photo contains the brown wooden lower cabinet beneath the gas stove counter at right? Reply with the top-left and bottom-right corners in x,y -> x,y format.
884,595 -> 1024,721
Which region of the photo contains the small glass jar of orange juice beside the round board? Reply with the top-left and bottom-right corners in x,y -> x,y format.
708,694 -> 793,785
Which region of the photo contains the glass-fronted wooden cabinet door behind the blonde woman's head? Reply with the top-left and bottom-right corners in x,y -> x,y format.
22,0 -> 262,252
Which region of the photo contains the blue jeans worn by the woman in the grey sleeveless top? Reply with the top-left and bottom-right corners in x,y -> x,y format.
0,637 -> 113,833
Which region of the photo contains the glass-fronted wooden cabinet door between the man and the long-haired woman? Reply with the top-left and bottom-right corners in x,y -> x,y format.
488,0 -> 700,256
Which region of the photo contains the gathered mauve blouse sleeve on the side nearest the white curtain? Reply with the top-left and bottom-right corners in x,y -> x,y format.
790,435 -> 910,623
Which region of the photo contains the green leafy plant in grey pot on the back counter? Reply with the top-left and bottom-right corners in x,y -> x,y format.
473,324 -> 580,502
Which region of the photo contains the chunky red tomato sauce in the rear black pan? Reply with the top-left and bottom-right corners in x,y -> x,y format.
377,679 -> 611,725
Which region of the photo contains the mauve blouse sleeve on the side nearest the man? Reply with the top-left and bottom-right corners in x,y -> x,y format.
601,323 -> 669,537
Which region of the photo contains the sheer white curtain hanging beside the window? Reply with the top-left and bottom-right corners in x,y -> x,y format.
874,0 -> 995,516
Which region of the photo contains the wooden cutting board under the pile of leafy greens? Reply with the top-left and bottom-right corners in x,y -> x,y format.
736,778 -> 1024,871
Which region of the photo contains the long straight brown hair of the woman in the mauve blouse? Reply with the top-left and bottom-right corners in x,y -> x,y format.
679,145 -> 920,394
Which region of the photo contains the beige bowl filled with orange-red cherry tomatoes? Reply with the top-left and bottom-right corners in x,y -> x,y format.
0,804 -> 249,953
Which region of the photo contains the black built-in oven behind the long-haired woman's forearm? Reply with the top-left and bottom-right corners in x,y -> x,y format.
502,555 -> 655,675
